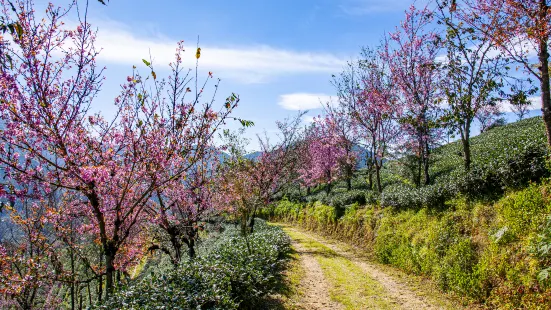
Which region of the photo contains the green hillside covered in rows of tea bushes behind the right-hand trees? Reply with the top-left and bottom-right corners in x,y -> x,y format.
283,117 -> 549,208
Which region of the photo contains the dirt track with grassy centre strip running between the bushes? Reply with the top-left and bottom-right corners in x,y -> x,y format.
281,225 -> 459,309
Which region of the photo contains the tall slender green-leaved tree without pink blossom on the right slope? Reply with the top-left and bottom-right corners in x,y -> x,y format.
437,1 -> 509,171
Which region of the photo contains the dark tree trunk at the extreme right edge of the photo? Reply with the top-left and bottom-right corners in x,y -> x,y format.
538,31 -> 551,148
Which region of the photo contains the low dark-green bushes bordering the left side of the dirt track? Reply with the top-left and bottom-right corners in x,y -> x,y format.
98,219 -> 290,309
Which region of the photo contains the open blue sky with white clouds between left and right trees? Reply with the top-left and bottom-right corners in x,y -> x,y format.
38,0 -> 544,150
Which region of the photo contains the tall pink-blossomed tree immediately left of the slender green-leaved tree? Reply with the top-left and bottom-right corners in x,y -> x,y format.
382,6 -> 442,184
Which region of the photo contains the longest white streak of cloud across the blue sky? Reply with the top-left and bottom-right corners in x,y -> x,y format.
90,22 -> 346,83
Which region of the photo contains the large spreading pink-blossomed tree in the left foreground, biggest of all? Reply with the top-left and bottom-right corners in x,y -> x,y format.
0,0 -> 239,297
